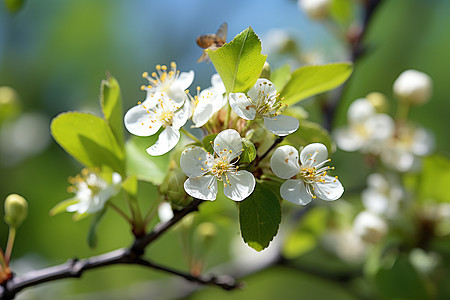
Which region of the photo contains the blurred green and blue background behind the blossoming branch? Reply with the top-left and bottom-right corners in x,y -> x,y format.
0,0 -> 450,299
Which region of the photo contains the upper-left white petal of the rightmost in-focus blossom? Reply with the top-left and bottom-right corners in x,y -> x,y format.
270,145 -> 300,179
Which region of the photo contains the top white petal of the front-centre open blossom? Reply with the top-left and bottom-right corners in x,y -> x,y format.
214,129 -> 242,162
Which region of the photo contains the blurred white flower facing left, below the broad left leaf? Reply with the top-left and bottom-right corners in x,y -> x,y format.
66,169 -> 122,215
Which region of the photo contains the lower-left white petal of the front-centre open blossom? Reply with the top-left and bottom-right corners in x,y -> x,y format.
184,175 -> 217,201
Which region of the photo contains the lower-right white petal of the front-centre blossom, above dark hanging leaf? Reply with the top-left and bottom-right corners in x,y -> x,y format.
223,171 -> 255,201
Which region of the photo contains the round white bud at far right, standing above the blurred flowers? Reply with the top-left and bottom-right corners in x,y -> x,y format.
394,70 -> 433,105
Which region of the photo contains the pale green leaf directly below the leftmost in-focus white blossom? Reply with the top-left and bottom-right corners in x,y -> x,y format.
125,134 -> 170,185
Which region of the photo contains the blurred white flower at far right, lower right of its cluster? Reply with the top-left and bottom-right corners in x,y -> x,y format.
380,124 -> 435,172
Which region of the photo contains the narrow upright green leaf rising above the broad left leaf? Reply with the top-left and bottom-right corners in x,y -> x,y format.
100,76 -> 124,149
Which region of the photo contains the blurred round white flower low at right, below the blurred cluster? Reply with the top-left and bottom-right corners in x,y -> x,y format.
353,211 -> 388,244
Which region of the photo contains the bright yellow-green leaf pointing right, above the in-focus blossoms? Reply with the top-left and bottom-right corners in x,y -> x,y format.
280,62 -> 353,105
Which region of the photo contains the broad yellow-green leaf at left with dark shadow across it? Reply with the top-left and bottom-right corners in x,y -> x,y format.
50,112 -> 124,176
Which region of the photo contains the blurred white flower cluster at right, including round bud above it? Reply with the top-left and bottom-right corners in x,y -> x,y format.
334,70 -> 435,172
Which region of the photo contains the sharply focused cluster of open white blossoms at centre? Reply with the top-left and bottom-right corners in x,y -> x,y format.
125,63 -> 343,205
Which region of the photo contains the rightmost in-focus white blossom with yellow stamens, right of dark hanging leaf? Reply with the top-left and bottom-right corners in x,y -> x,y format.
270,143 -> 344,205
